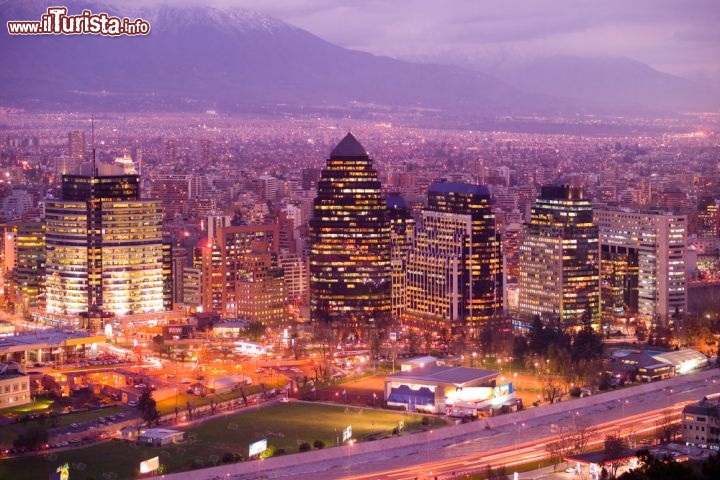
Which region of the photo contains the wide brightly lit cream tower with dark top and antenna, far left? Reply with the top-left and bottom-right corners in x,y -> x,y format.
45,162 -> 168,328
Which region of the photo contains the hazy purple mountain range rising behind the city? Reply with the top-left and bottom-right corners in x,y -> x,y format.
0,0 -> 720,118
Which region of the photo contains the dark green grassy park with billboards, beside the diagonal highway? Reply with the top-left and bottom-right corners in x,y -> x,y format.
0,402 -> 445,480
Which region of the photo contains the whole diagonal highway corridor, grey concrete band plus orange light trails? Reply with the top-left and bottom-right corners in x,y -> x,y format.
148,368 -> 720,480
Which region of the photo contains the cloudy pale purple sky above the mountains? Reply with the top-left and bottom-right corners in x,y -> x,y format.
128,0 -> 720,81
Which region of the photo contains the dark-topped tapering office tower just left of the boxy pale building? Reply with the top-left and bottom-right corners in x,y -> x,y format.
519,186 -> 600,328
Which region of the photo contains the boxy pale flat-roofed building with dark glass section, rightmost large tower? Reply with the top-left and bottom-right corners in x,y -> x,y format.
595,209 -> 687,324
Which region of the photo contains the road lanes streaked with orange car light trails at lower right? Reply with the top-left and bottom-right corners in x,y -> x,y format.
256,369 -> 720,480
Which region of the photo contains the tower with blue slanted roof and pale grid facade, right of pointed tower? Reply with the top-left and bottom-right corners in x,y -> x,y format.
406,182 -> 502,338
